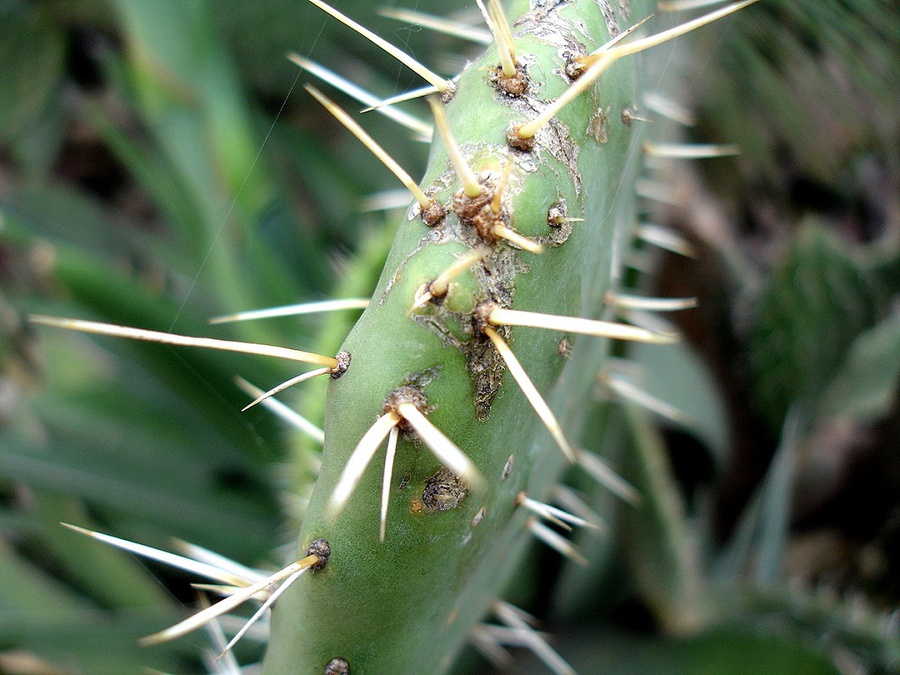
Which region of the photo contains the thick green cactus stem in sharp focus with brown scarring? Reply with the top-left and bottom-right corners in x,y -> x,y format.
264,0 -> 768,673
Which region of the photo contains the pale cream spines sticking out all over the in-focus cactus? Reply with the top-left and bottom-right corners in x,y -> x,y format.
33,0 -> 753,672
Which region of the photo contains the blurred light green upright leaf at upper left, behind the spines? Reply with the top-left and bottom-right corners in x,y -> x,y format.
108,0 -> 306,311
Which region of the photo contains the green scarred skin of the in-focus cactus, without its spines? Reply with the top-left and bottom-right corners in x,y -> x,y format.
263,0 -> 648,675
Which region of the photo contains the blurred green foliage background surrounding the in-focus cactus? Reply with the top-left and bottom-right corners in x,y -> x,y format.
0,0 -> 900,673
